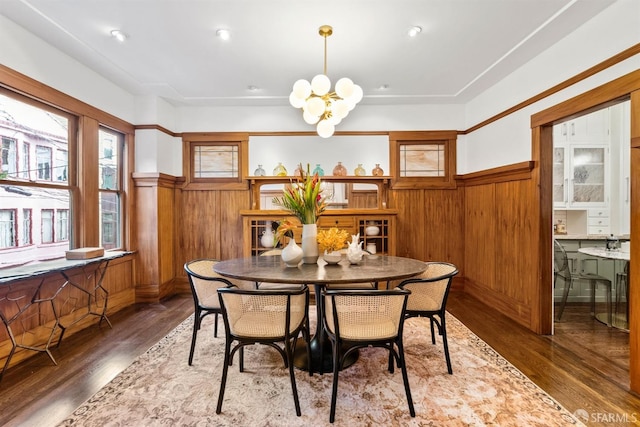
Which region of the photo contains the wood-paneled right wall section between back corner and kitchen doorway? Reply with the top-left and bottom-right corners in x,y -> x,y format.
463,162 -> 539,331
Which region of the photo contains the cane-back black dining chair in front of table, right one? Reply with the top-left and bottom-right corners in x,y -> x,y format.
323,289 -> 416,423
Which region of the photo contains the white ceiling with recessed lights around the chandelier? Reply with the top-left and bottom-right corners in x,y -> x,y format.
0,0 -> 615,106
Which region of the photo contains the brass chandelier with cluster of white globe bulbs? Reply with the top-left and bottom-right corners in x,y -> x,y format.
289,25 -> 363,138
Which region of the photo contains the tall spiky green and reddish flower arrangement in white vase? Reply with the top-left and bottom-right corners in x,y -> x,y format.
273,164 -> 327,224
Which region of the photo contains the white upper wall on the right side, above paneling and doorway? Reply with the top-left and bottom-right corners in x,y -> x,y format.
458,0 -> 640,173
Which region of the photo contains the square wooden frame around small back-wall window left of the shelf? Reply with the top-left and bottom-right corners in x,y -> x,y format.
182,132 -> 249,190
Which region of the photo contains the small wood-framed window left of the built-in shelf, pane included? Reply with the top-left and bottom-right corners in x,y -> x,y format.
182,133 -> 249,190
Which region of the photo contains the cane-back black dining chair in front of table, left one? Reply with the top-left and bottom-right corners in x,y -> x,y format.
216,285 -> 311,416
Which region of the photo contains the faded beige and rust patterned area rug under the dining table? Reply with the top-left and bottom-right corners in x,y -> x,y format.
60,313 -> 582,427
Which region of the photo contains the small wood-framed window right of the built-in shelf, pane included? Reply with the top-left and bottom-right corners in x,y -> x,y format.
389,131 -> 457,189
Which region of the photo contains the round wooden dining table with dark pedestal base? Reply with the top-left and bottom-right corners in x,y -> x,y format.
214,255 -> 427,374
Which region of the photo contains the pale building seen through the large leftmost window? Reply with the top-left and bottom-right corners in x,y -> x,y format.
0,94 -> 71,268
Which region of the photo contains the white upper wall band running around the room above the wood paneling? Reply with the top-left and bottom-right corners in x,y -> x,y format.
0,0 -> 640,175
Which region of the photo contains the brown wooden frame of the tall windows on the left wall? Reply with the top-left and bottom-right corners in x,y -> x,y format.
0,65 -> 136,264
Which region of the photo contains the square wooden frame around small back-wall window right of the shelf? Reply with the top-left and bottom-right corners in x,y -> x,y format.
389,131 -> 458,189
